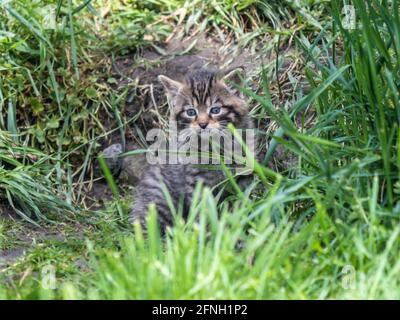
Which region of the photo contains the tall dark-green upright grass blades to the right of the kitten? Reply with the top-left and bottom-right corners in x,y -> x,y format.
253,1 -> 400,221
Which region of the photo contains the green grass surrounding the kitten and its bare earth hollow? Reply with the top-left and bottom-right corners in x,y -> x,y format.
0,0 -> 400,299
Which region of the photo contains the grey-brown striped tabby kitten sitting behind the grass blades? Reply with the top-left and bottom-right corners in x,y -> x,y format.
131,69 -> 253,230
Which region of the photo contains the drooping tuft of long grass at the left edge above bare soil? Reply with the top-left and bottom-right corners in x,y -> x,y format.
0,130 -> 75,225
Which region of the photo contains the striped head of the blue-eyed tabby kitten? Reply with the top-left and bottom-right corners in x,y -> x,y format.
158,68 -> 252,133
